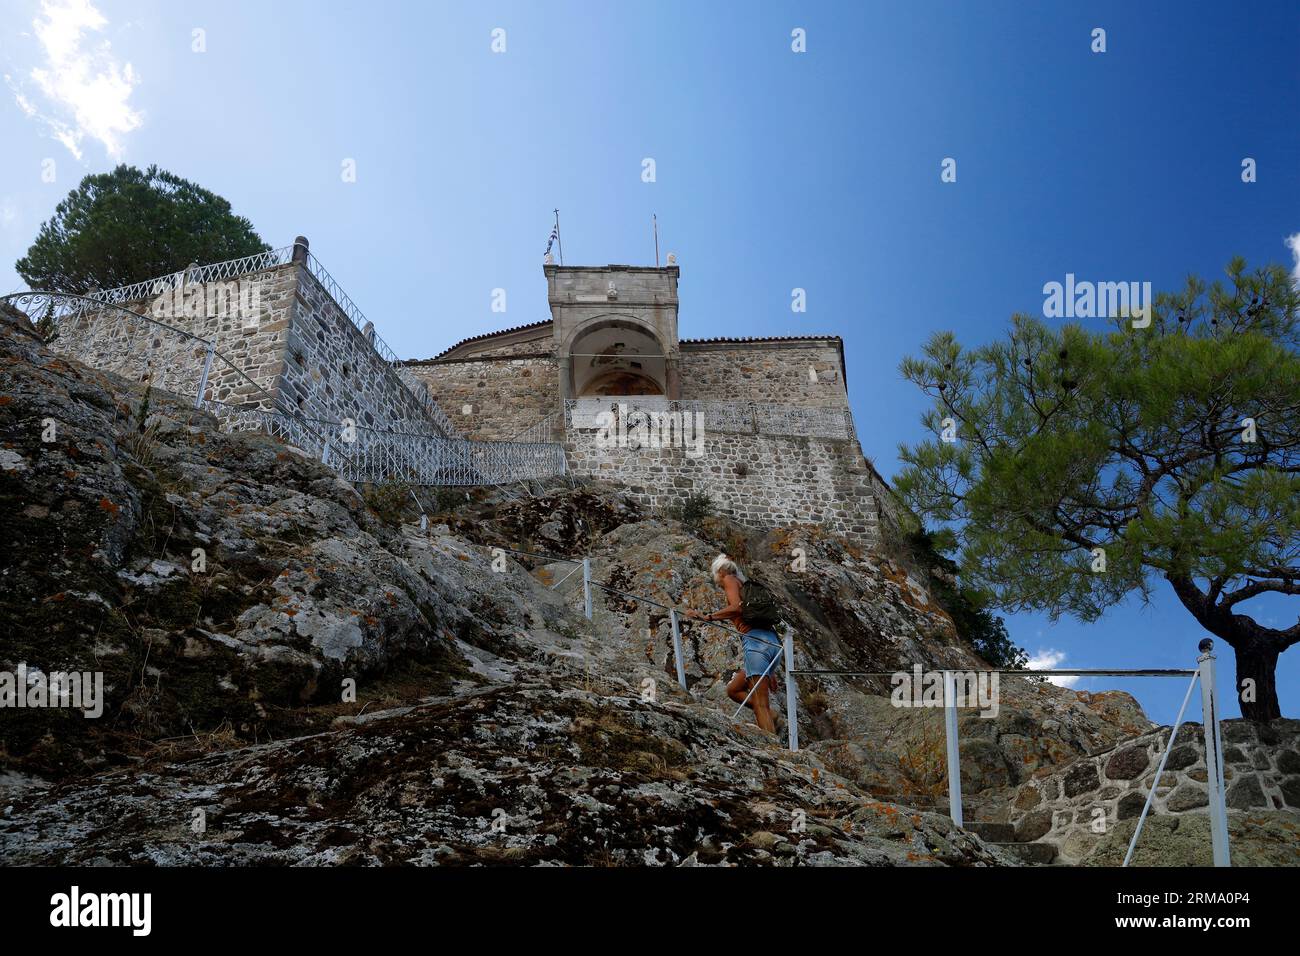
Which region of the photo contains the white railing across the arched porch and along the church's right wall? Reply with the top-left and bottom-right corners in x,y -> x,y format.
564,395 -> 855,438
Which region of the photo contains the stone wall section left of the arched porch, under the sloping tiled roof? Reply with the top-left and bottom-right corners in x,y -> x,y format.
407,356 -> 560,441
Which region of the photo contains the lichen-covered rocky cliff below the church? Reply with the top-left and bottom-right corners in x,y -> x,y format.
0,317 -> 1279,865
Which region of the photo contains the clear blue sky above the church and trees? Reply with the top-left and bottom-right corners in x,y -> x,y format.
0,0 -> 1300,721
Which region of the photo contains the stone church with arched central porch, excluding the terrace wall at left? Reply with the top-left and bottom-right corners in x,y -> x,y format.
404,258 -> 894,542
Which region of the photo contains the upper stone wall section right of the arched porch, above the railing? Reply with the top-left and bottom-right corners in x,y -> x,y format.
681,338 -> 849,407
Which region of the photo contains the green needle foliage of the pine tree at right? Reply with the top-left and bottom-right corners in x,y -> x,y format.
896,259 -> 1300,717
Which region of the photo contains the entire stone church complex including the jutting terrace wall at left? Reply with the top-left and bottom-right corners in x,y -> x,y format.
38,237 -> 898,544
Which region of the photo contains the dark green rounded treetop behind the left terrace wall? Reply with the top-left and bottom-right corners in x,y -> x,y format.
14,165 -> 270,293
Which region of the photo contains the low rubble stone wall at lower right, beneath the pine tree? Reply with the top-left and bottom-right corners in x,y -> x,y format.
1009,719 -> 1300,865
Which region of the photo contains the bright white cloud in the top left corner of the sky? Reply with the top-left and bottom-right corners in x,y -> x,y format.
5,0 -> 143,160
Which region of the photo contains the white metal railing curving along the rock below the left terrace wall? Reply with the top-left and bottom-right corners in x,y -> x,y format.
0,293 -> 566,485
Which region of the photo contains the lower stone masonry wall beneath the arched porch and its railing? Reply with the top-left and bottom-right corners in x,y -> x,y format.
566,429 -> 880,546
